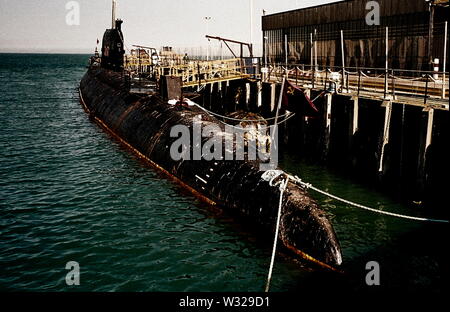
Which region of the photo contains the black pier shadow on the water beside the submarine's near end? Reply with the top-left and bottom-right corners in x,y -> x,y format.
281,155 -> 449,298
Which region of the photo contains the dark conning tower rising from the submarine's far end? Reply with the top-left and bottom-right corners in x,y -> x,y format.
101,19 -> 125,71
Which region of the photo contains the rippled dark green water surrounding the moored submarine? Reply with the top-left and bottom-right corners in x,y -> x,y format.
0,54 -> 448,291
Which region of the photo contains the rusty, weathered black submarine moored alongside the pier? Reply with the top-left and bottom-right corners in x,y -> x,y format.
79,13 -> 342,268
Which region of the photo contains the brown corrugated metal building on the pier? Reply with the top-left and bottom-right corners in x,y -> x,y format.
262,0 -> 449,70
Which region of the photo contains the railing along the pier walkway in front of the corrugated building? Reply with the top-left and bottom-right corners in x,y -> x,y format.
263,63 -> 449,108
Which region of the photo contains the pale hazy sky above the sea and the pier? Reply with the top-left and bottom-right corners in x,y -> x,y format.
0,0 -> 336,53
